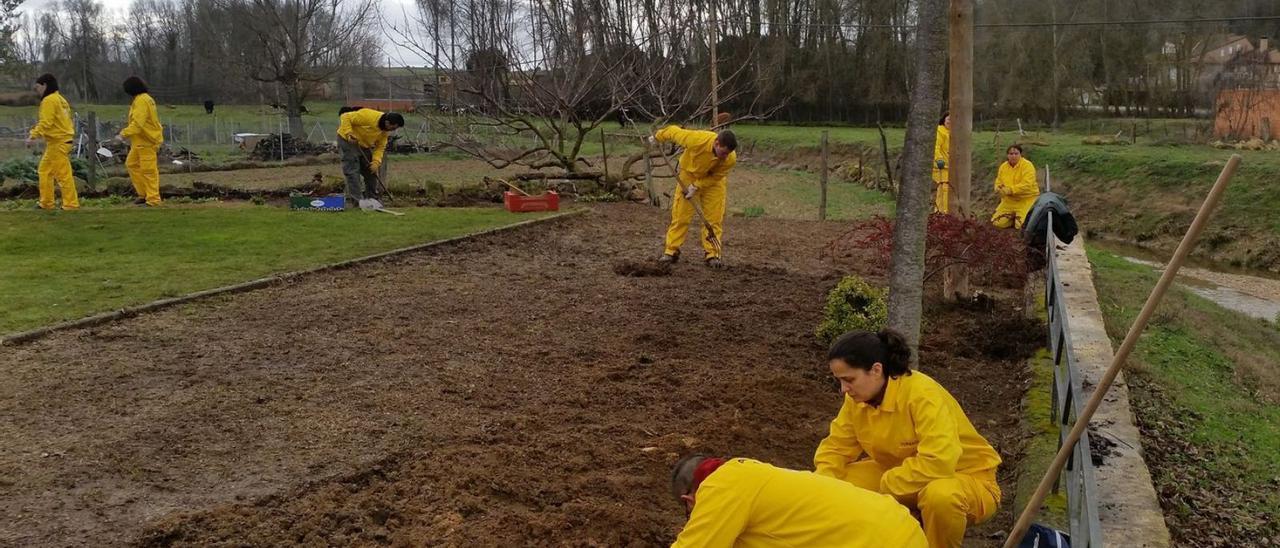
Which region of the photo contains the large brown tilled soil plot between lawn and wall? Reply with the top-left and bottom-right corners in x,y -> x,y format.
0,205 -> 1041,547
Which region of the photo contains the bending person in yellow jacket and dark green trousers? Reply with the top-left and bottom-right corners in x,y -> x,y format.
338,109 -> 404,209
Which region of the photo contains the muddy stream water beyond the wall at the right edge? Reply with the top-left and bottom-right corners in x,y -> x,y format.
1097,242 -> 1280,321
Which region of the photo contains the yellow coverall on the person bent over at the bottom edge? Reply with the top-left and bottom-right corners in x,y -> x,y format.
672,458 -> 925,548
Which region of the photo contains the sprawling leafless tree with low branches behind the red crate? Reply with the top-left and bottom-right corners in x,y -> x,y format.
393,0 -> 777,189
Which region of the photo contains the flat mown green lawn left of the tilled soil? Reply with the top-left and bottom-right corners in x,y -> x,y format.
0,204 -> 536,333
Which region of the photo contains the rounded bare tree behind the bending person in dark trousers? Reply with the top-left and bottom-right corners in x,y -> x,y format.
214,0 -> 376,136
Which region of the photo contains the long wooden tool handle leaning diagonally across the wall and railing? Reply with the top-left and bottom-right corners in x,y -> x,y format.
1005,154 -> 1240,548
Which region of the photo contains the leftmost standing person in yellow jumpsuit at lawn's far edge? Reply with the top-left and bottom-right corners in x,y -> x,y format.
27,74 -> 79,210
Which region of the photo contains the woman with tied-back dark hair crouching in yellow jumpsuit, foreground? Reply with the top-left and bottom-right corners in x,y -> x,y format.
813,329 -> 1000,548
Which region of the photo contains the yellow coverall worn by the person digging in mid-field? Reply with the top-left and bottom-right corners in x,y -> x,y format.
654,125 -> 737,259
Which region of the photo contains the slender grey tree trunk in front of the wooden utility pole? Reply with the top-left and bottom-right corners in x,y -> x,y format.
888,0 -> 947,361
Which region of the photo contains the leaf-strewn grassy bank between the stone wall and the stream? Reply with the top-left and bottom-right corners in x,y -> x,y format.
1089,250 -> 1280,540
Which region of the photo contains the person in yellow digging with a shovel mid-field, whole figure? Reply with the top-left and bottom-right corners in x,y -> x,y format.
649,125 -> 737,269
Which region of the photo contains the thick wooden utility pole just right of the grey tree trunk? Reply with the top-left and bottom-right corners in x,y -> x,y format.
943,0 -> 973,300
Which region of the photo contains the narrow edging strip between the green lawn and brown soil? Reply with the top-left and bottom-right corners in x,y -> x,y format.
0,207 -> 590,346
